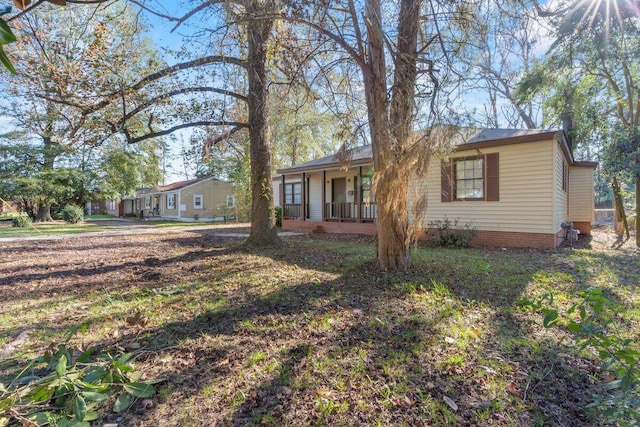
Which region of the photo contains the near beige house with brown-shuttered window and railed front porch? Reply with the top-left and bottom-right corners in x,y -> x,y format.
274,129 -> 597,248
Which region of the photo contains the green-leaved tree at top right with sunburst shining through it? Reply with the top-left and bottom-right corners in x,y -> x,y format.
520,0 -> 640,237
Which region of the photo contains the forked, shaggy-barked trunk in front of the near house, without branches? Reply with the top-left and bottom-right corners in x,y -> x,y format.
364,0 -> 420,269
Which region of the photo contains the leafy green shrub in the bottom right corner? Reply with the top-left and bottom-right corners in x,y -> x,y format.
519,289 -> 640,426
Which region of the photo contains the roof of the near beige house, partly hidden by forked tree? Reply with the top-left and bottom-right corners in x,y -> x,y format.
277,128 -> 562,174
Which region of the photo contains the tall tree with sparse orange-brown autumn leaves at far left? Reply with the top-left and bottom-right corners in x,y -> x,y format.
2,2 -> 162,221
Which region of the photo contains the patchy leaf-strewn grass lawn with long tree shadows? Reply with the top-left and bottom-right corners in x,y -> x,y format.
0,231 -> 640,426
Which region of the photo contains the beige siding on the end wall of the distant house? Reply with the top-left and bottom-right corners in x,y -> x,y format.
180,180 -> 232,219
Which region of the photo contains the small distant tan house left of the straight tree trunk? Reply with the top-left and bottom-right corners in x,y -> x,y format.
120,177 -> 235,222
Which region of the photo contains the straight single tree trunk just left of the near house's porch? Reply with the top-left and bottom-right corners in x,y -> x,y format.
246,0 -> 279,246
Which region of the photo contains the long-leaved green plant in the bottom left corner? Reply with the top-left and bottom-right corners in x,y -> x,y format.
0,345 -> 163,427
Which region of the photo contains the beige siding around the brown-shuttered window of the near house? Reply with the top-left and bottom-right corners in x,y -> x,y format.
422,140 -> 556,233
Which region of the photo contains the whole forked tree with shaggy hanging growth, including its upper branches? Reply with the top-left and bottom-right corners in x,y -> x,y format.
289,0 -> 464,269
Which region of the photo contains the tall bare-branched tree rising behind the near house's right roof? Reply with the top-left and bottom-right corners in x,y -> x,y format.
445,0 -> 549,129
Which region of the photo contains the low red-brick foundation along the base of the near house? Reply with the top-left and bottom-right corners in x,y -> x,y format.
282,220 -> 568,249
